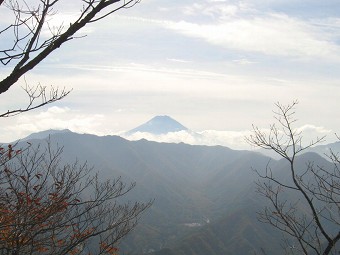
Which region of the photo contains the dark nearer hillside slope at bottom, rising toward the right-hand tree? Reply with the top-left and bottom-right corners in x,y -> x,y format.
152,204 -> 285,255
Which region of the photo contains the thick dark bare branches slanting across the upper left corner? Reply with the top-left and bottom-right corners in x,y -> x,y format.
0,0 -> 140,94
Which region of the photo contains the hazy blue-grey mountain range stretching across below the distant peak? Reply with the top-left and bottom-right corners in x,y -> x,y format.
14,132 -> 338,255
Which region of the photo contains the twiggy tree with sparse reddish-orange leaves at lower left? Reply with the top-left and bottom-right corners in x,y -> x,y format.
0,142 -> 151,255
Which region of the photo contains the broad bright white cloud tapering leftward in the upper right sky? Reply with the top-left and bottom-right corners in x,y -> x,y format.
166,14 -> 340,60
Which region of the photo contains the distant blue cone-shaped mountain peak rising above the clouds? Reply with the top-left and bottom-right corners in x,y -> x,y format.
127,115 -> 188,135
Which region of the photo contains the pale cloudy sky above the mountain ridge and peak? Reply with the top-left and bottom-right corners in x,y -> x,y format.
0,0 -> 340,149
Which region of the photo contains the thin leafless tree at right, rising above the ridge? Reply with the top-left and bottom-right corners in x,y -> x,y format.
246,101 -> 340,255
